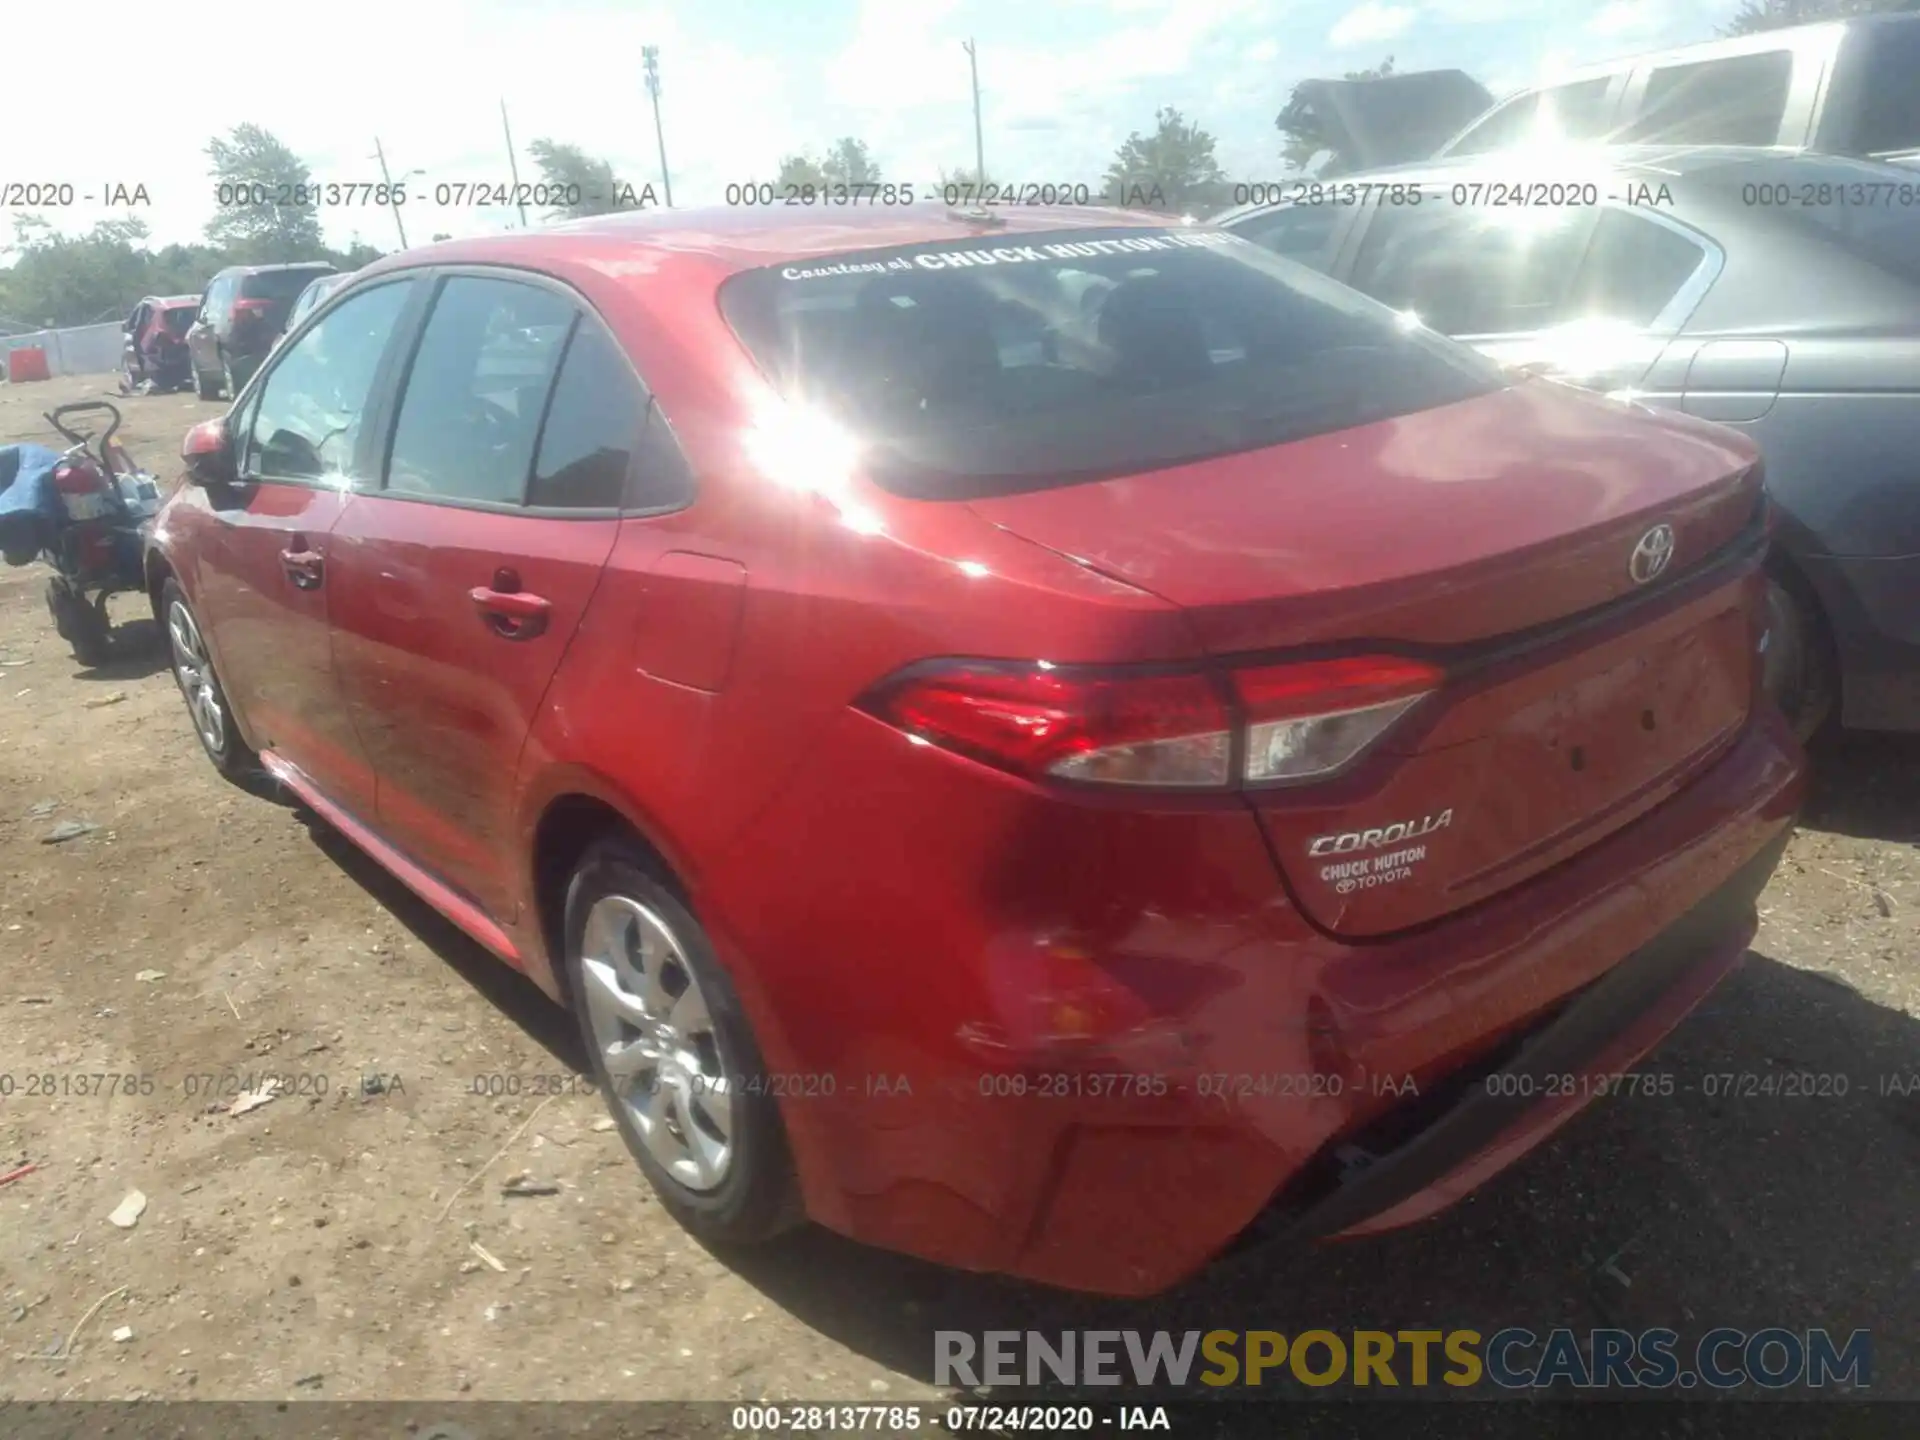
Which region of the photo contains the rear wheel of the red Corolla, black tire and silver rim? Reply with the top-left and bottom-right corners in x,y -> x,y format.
564,839 -> 804,1246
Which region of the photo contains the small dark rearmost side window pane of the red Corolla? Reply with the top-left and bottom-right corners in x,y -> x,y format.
526,319 -> 647,509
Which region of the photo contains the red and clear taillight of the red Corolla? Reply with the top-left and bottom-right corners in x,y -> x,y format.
860,657 -> 1442,789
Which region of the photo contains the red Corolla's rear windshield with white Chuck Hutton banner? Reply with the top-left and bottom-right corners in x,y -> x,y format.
720,227 -> 1505,499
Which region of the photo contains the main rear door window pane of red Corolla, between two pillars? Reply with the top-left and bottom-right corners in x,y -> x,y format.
384,275 -> 574,505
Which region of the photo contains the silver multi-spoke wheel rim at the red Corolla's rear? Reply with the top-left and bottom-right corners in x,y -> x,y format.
580,895 -> 733,1190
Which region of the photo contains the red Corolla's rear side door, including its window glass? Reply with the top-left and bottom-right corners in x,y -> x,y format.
321,269 -> 625,922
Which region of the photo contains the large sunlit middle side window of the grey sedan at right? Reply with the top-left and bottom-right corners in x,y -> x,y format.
1350,204 -> 1590,336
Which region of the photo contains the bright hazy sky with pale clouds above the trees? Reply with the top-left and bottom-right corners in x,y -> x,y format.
0,0 -> 1738,248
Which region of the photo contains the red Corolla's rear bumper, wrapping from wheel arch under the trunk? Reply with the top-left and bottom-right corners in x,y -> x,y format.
695,707 -> 1803,1294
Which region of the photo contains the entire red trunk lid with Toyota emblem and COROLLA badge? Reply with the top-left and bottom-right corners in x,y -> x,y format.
972,382 -> 1761,937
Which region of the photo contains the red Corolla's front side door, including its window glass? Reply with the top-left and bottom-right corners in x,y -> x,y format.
194,280 -> 415,816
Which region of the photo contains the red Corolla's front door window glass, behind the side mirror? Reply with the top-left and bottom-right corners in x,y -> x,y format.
244,280 -> 413,484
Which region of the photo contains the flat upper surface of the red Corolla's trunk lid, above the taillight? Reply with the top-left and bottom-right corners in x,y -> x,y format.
968,380 -> 1759,655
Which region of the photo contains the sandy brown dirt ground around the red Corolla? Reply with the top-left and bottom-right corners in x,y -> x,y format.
0,366 -> 1920,1400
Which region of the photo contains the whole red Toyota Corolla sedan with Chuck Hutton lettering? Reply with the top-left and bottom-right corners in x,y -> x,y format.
148,207 -> 1803,1294
